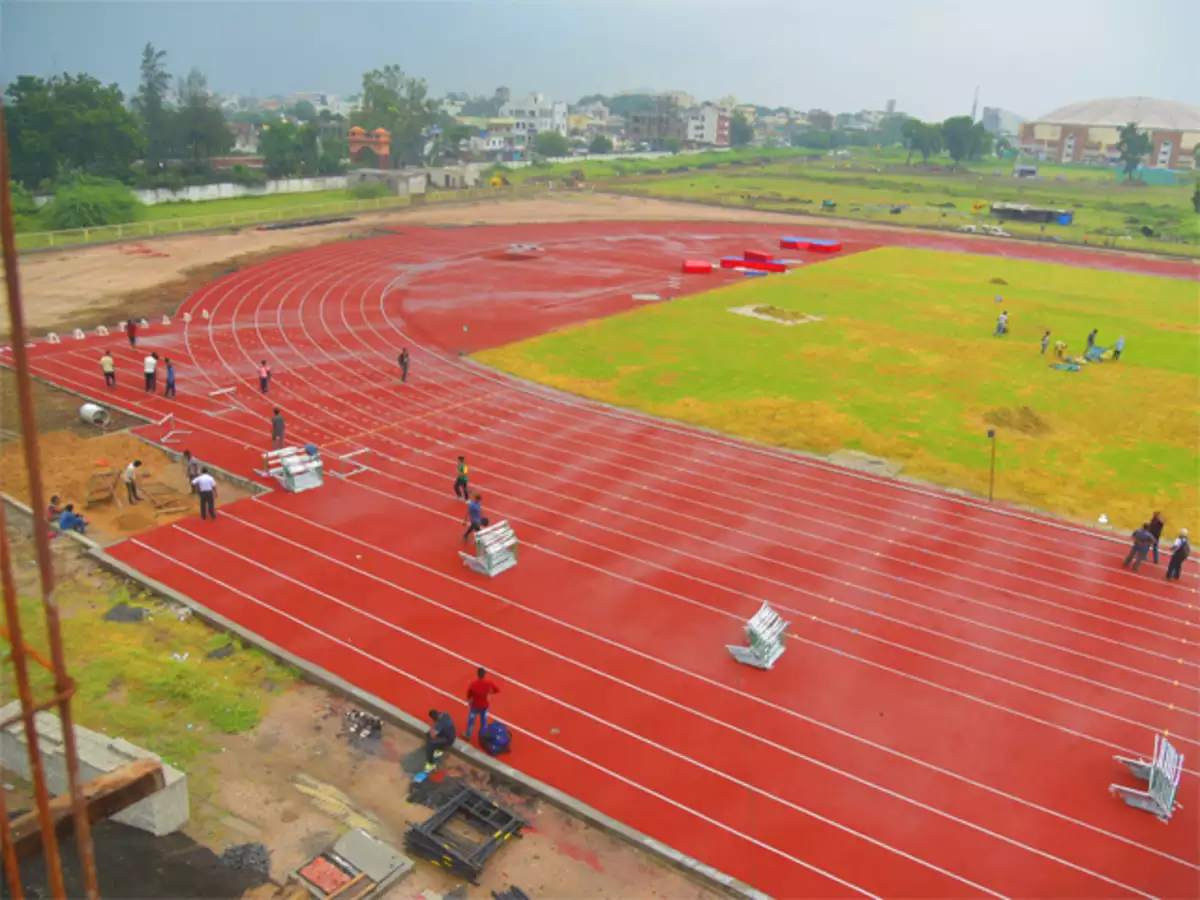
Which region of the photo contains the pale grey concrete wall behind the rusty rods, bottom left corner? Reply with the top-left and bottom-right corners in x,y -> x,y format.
0,701 -> 190,838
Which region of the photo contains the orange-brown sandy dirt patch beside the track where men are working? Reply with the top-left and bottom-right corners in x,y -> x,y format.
0,431 -> 248,544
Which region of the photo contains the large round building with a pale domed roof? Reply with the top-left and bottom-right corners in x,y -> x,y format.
1019,97 -> 1200,169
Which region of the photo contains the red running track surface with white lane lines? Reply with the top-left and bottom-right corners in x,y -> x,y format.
11,223 -> 1200,898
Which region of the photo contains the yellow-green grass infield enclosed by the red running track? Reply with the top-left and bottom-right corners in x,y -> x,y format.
479,248 -> 1200,528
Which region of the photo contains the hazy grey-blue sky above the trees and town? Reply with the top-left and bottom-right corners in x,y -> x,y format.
0,0 -> 1200,119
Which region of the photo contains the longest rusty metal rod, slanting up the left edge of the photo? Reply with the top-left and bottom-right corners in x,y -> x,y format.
0,98 -> 100,900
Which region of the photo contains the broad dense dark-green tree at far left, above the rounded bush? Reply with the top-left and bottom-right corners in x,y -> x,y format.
5,74 -> 143,190
